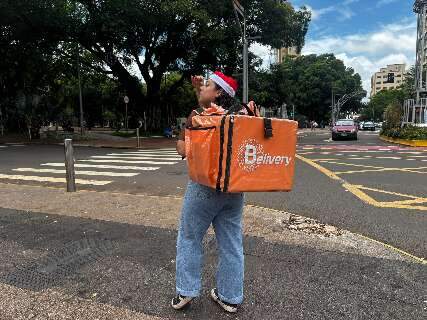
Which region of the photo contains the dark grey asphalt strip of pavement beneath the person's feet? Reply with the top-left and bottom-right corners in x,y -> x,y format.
0,208 -> 426,320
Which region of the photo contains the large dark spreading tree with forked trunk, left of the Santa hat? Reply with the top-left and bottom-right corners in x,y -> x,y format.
2,0 -> 310,130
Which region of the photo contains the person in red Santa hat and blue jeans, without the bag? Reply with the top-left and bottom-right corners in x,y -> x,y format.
172,71 -> 258,313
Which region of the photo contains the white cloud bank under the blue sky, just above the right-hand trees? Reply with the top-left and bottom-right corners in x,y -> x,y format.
303,20 -> 416,94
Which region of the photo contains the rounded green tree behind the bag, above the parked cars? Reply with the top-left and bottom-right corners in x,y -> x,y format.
254,54 -> 363,122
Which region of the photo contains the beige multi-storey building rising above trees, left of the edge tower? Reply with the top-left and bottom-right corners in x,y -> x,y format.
371,64 -> 406,98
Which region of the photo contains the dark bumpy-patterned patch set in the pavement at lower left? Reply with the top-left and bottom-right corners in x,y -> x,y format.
2,238 -> 114,291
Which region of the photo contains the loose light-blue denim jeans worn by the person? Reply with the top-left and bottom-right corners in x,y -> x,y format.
176,181 -> 244,304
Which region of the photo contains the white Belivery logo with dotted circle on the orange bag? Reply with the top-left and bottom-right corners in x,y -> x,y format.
238,139 -> 292,172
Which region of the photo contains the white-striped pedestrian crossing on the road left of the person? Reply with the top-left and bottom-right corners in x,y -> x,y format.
0,148 -> 182,186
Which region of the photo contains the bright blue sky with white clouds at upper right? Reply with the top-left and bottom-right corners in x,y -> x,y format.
251,0 -> 417,96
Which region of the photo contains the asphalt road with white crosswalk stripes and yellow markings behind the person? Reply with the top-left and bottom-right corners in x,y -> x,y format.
0,131 -> 427,258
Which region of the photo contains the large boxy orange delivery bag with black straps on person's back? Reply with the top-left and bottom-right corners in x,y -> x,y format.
185,110 -> 298,193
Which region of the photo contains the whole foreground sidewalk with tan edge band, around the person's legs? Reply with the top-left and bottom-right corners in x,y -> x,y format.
0,184 -> 427,320
